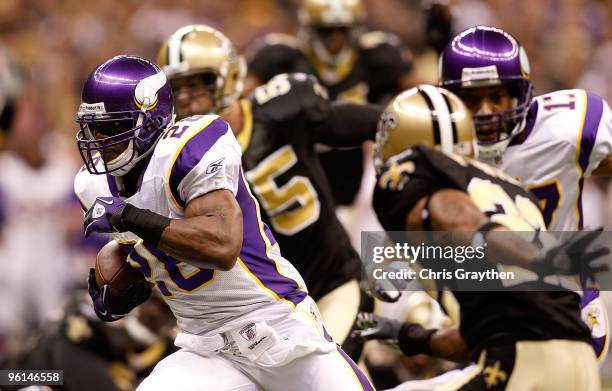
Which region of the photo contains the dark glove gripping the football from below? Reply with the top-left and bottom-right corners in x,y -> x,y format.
87,268 -> 152,322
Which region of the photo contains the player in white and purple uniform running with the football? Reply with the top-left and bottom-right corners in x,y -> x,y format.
75,56 -> 372,390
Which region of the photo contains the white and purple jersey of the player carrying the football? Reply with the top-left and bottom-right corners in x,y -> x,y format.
75,115 -> 307,335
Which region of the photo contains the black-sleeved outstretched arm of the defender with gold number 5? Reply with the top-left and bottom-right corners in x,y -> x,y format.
314,103 -> 381,147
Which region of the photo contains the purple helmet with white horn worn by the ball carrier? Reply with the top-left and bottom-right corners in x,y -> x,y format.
76,55 -> 174,176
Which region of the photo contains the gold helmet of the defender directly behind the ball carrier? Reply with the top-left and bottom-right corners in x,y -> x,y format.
157,24 -> 246,112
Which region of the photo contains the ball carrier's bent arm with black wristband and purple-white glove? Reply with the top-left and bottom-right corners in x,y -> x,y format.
85,188 -> 242,270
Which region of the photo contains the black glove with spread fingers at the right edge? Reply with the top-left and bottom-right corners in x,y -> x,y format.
532,228 -> 610,279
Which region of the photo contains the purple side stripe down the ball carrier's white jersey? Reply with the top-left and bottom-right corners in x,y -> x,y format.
236,171 -> 306,304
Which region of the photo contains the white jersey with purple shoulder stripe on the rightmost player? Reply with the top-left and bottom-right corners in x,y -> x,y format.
496,90 -> 612,231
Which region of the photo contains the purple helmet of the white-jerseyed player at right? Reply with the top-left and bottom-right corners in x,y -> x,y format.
439,26 -> 533,159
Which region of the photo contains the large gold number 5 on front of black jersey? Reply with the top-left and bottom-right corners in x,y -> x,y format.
246,145 -> 321,236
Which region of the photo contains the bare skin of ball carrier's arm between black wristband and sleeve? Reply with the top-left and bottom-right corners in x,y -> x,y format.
158,214 -> 242,270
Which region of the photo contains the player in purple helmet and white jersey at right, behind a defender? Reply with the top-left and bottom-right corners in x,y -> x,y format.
439,26 -> 612,366
